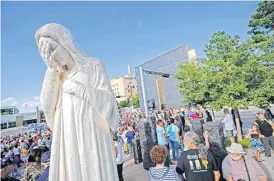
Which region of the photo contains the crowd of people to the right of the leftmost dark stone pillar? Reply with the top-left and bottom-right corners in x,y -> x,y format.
149,108 -> 274,181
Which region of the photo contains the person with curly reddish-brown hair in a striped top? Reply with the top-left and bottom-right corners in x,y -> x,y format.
149,146 -> 180,181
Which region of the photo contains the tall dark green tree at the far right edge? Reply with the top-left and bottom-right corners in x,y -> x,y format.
249,1 -> 274,108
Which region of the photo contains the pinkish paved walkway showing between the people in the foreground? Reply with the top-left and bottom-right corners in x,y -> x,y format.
123,150 -> 274,181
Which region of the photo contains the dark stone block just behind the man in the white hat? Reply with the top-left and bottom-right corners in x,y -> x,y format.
203,121 -> 225,149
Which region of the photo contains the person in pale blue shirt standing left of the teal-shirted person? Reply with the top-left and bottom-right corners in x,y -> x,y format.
157,120 -> 169,166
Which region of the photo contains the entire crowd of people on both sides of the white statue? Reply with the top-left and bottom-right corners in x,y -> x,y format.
1,107 -> 274,181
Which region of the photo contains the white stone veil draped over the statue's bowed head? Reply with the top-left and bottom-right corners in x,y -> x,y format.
35,23 -> 83,71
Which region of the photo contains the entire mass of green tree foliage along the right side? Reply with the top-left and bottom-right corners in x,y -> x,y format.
176,5 -> 274,110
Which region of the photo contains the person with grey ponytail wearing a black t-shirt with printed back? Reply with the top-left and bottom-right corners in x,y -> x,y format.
176,132 -> 220,181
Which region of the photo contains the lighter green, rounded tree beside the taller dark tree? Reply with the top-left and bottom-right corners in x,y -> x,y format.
176,31 -> 256,140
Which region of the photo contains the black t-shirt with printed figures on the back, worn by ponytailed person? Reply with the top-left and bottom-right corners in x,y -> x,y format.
176,149 -> 219,181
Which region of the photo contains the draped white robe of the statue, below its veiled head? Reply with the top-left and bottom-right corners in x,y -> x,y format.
41,59 -> 119,181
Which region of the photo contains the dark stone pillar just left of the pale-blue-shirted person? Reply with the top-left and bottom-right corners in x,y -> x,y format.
138,118 -> 154,169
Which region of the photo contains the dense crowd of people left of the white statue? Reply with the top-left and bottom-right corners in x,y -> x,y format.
1,128 -> 52,181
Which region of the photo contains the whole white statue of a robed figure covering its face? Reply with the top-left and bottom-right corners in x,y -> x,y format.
35,24 -> 119,181
